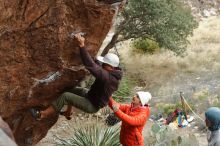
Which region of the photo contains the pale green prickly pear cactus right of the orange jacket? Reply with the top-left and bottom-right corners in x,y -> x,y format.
147,124 -> 199,146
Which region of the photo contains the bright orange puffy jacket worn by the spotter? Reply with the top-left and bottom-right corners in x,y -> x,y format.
109,98 -> 150,146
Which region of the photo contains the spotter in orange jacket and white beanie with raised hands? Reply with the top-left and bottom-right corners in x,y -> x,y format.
109,91 -> 152,146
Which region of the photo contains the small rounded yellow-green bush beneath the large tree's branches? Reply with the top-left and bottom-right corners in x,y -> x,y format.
133,39 -> 159,54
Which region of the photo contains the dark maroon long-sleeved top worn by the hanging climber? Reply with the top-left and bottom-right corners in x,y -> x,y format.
80,48 -> 122,108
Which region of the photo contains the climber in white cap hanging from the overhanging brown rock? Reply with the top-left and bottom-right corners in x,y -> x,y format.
30,34 -> 122,120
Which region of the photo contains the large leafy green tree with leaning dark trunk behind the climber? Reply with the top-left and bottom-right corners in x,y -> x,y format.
102,0 -> 198,56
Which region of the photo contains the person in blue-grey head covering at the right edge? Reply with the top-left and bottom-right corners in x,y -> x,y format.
205,107 -> 220,146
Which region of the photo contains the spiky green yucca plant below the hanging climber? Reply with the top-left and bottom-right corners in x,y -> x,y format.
57,124 -> 121,146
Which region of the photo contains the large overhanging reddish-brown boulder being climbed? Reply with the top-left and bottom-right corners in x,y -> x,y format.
0,0 -> 120,146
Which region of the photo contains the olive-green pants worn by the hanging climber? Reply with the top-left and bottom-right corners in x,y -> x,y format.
52,87 -> 99,113
